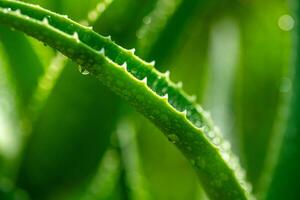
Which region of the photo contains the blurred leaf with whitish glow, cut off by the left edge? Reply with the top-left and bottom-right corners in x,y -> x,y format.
0,43 -> 21,181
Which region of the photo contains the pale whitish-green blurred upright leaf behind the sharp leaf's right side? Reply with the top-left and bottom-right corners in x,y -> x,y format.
204,16 -> 240,148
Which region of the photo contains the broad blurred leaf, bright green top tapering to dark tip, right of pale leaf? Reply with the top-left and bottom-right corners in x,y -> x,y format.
234,1 -> 289,188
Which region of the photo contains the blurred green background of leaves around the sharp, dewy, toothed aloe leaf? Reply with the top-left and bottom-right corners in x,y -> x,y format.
0,0 -> 300,200
